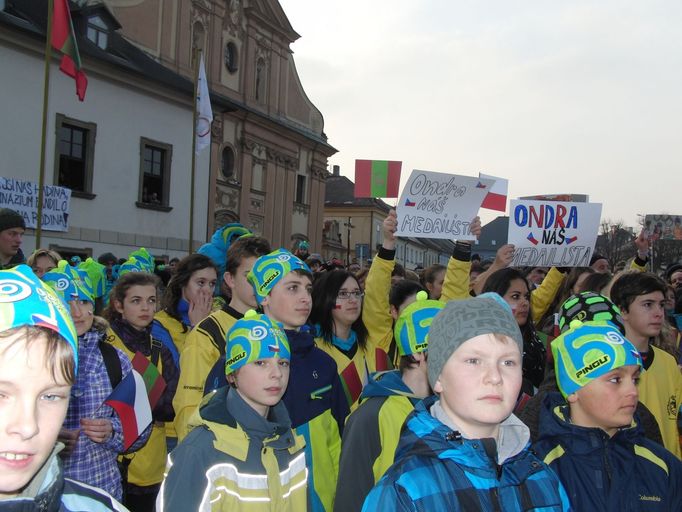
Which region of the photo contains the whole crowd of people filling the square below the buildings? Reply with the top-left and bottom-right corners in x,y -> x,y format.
0,205 -> 682,512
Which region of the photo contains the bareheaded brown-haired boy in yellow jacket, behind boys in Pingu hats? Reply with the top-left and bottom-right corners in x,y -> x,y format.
173,237 -> 270,440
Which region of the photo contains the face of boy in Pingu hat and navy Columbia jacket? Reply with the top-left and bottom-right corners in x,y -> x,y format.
568,365 -> 640,436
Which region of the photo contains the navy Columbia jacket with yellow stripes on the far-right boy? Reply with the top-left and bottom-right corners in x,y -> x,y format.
533,393 -> 682,512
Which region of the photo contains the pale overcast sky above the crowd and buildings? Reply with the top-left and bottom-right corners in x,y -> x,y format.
281,0 -> 682,225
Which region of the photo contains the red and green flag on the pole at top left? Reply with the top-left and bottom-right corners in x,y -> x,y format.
52,0 -> 88,101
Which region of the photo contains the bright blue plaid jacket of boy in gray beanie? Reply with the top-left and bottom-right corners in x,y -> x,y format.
362,396 -> 570,512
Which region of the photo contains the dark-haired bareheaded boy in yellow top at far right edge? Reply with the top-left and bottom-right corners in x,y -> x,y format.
611,272 -> 682,459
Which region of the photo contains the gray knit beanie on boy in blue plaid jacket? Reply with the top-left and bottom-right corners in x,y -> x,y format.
429,293 -> 523,387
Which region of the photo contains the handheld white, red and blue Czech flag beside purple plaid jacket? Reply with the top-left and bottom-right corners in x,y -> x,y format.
104,369 -> 152,450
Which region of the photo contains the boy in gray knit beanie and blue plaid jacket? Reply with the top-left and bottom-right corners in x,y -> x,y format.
363,294 -> 570,511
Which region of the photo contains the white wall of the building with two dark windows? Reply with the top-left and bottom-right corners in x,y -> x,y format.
0,45 -> 209,256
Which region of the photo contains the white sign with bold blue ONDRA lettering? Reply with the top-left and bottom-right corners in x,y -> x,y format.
507,199 -> 601,267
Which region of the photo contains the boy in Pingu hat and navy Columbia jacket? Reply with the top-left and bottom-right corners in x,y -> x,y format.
533,320 -> 682,512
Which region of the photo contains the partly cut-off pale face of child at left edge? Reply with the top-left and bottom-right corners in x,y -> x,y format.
0,332 -> 71,499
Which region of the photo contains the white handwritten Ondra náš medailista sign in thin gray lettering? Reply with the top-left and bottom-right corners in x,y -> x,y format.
396,169 -> 494,240
